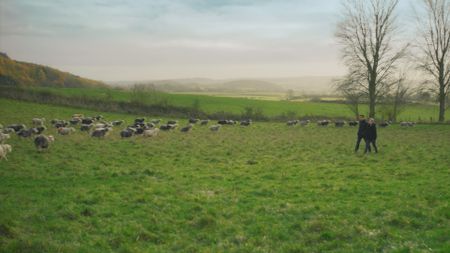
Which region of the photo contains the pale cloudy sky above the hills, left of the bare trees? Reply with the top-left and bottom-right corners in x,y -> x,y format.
0,0 -> 411,81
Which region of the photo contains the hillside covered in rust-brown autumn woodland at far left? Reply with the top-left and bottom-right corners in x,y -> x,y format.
0,52 -> 105,87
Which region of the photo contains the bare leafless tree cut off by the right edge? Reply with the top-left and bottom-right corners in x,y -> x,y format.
417,0 -> 450,122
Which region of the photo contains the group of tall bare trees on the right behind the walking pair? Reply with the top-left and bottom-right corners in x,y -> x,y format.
335,0 -> 450,122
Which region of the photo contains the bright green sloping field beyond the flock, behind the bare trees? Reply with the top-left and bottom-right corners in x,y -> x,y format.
9,88 -> 450,121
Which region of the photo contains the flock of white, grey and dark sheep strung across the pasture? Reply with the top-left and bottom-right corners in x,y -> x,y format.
0,114 -> 415,160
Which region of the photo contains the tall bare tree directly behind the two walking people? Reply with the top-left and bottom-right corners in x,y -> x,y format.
336,0 -> 407,117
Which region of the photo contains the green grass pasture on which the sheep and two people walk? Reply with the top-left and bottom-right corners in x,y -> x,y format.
0,99 -> 450,252
